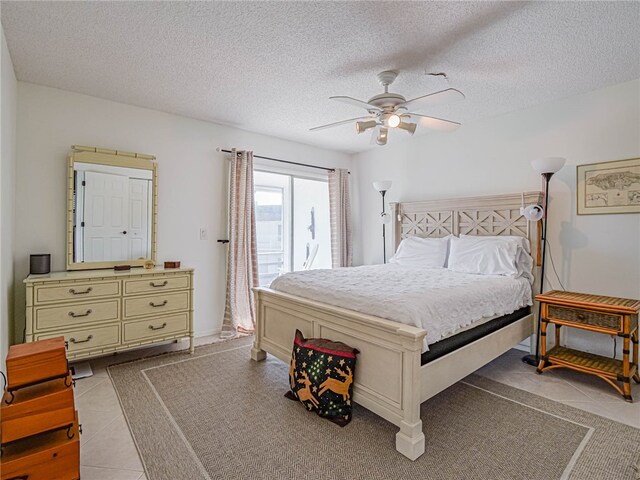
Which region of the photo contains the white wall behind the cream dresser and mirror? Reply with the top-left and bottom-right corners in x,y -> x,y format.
14,82 -> 351,340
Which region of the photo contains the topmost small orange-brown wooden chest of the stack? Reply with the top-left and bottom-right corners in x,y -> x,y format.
7,337 -> 69,391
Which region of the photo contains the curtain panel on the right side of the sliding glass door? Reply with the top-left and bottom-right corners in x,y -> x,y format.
329,168 -> 353,268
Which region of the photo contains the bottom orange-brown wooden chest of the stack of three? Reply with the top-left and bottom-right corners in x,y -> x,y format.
1,415 -> 80,480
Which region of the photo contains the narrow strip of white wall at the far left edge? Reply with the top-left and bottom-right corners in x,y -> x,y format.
0,27 -> 17,371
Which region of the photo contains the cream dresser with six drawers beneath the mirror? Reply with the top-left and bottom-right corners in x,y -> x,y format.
24,268 -> 193,359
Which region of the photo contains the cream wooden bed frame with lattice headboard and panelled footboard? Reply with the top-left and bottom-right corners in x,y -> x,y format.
251,192 -> 542,460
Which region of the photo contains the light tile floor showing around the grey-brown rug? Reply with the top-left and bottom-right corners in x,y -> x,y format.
76,336 -> 640,480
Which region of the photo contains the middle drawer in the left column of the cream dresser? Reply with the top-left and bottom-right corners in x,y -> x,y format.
34,299 -> 120,331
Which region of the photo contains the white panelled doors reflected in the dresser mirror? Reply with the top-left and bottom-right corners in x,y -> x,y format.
83,172 -> 150,262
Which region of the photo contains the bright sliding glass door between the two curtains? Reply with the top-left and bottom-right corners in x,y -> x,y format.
254,171 -> 331,286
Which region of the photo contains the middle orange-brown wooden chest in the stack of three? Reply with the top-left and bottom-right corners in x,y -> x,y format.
0,375 -> 75,445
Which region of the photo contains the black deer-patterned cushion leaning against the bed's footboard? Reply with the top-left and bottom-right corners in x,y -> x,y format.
285,330 -> 359,426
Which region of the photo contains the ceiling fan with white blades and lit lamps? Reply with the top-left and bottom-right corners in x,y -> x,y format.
310,70 -> 464,145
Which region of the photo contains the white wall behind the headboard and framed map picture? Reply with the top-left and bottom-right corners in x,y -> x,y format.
353,80 -> 640,358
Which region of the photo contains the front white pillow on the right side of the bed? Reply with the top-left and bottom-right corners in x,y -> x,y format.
448,235 -> 522,277
